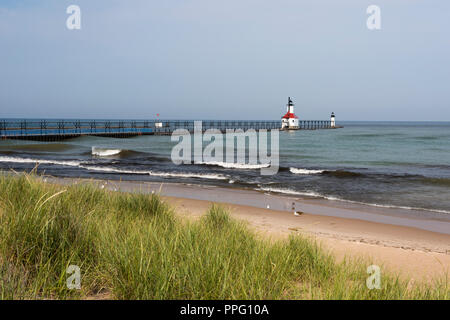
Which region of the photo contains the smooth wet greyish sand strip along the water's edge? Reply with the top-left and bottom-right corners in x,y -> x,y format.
44,176 -> 450,235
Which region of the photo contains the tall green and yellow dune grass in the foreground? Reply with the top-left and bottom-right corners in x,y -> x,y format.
0,174 -> 449,299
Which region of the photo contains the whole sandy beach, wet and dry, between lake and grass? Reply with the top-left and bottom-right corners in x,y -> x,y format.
47,178 -> 450,282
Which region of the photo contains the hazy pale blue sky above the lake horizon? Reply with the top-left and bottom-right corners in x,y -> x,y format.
0,0 -> 450,121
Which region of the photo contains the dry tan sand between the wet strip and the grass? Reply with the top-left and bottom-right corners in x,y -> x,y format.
168,197 -> 450,281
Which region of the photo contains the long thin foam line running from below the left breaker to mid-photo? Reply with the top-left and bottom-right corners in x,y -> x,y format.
81,165 -> 228,180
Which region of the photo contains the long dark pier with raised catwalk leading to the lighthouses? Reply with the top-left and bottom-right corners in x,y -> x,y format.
0,119 -> 334,141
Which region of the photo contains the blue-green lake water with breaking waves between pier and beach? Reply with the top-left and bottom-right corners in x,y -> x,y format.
0,122 -> 450,216
